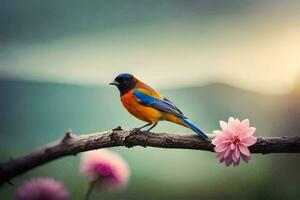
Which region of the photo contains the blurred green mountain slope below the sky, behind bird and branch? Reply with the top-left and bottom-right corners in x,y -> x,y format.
0,80 -> 300,199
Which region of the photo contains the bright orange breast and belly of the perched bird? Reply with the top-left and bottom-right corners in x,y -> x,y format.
121,90 -> 163,123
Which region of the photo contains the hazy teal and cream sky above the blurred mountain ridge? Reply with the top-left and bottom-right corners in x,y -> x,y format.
0,0 -> 300,93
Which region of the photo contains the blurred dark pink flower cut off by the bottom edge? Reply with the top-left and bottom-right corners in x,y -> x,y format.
15,178 -> 69,200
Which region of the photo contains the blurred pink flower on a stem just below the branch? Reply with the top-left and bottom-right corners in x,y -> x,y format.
81,149 -> 130,190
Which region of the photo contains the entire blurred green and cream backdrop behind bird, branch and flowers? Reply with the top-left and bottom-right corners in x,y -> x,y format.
0,0 -> 300,200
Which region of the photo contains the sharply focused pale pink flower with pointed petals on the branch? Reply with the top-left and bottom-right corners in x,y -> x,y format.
212,117 -> 256,166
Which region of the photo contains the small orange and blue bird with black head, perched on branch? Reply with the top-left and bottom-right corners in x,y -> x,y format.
109,73 -> 208,140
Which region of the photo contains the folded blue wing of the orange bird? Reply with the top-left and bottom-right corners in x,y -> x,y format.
133,89 -> 185,118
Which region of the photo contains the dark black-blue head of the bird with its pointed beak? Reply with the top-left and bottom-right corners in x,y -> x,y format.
109,73 -> 138,95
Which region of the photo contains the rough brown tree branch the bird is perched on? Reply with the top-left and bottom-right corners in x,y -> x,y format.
0,127 -> 300,185
